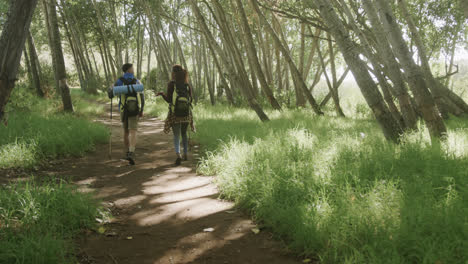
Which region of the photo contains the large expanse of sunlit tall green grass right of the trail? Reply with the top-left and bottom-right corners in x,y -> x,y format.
194,106 -> 468,263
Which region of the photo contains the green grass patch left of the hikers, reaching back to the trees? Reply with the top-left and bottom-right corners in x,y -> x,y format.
0,86 -> 109,169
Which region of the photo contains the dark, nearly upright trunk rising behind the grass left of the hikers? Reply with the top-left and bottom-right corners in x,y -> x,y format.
48,0 -> 73,112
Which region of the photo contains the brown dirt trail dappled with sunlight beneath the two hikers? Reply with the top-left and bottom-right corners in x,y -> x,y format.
61,105 -> 300,264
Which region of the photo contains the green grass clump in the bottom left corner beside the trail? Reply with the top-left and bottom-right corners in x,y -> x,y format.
0,181 -> 101,264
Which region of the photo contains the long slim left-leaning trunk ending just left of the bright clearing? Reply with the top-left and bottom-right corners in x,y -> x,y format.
250,0 -> 323,115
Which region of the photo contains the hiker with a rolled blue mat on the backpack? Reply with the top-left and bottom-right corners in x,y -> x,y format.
109,63 -> 145,165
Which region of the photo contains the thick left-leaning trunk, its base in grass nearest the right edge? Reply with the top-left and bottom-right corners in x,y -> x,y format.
372,0 -> 447,139
